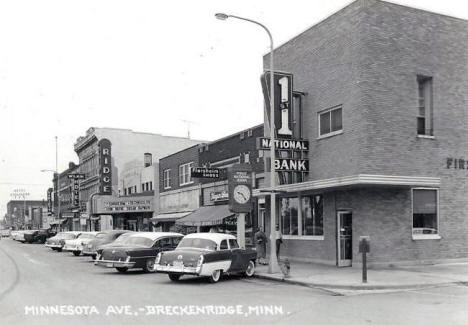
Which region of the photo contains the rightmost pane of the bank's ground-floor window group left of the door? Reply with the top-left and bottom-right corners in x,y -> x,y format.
302,195 -> 323,236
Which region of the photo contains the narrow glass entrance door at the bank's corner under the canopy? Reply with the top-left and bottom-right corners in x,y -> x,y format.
336,211 -> 353,266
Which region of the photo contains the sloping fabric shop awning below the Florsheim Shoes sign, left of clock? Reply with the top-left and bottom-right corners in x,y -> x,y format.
176,204 -> 234,226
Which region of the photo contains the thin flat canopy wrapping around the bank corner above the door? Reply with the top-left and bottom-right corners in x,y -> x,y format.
253,174 -> 440,197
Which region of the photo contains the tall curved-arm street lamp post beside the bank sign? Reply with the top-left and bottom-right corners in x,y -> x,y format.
215,13 -> 279,273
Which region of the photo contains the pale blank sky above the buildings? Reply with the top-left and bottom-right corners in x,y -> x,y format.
0,0 -> 468,219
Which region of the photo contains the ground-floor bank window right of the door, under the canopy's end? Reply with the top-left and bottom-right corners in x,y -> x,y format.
413,189 -> 439,237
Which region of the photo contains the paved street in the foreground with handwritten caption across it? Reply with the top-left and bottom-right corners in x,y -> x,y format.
0,239 -> 468,325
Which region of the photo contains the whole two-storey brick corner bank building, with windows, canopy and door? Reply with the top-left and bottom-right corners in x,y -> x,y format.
254,0 -> 468,266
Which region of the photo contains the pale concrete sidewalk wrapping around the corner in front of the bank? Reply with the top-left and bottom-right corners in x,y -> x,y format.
255,262 -> 468,290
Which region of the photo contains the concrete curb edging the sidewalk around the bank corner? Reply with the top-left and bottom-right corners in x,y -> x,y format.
254,274 -> 460,290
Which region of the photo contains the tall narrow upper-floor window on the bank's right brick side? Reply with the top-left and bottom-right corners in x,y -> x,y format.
417,76 -> 434,136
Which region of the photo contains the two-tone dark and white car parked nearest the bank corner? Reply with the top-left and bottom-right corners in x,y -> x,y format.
155,233 -> 257,283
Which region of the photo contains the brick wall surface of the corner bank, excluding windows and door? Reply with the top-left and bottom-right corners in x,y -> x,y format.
264,0 -> 468,262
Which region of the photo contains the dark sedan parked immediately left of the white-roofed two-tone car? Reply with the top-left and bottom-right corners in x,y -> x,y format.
94,232 -> 183,273
